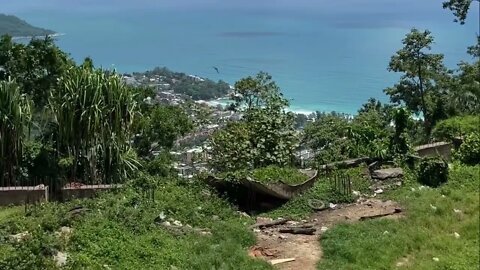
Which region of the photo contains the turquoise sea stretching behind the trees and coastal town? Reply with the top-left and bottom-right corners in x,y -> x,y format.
4,0 -> 478,113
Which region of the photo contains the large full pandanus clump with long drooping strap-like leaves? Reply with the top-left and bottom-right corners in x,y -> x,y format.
49,66 -> 138,183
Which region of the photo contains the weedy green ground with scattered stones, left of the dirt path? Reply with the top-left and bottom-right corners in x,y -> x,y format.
0,180 -> 271,269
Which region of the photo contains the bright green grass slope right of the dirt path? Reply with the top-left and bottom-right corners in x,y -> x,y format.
318,166 -> 480,270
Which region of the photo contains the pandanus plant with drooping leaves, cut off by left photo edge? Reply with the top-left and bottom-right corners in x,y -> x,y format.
0,81 -> 31,186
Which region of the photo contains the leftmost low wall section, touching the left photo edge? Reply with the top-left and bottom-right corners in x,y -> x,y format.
0,185 -> 48,206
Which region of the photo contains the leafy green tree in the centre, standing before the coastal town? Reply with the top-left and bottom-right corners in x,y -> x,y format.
210,72 -> 298,172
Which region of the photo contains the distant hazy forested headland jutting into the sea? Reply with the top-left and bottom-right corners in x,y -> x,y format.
0,14 -> 55,37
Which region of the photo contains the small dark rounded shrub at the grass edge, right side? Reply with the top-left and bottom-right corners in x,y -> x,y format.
418,158 -> 448,187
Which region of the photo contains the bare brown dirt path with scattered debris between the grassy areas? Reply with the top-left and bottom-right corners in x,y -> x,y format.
250,199 -> 402,270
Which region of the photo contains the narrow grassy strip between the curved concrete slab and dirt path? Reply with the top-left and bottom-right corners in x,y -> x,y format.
263,167 -> 370,219
